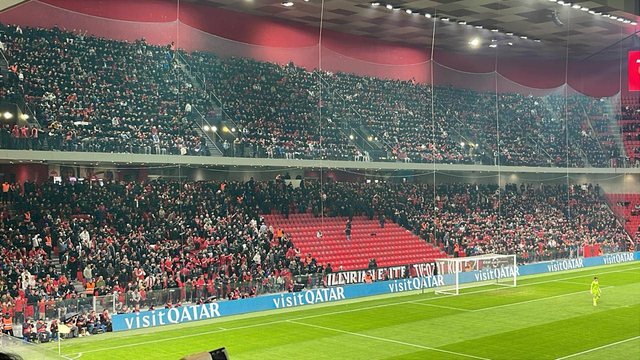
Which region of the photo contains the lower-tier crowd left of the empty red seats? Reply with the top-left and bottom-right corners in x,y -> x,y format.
0,177 -> 323,338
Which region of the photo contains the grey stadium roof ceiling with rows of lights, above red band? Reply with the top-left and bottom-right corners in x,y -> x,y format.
187,0 -> 640,58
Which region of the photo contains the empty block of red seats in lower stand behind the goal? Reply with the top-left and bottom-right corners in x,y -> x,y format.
264,214 -> 446,271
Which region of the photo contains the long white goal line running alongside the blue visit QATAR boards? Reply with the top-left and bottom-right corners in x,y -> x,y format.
58,267 -> 640,354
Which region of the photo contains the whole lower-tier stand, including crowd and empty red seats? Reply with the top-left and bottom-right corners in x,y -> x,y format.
0,179 -> 630,330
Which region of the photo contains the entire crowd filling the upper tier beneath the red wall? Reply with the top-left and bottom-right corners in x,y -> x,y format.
0,25 -> 619,167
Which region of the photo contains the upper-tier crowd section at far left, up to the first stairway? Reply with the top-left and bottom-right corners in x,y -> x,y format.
0,25 -> 209,155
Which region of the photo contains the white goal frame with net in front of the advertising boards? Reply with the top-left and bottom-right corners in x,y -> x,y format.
436,254 -> 518,295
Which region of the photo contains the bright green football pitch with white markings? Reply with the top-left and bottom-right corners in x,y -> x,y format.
6,264 -> 640,360
